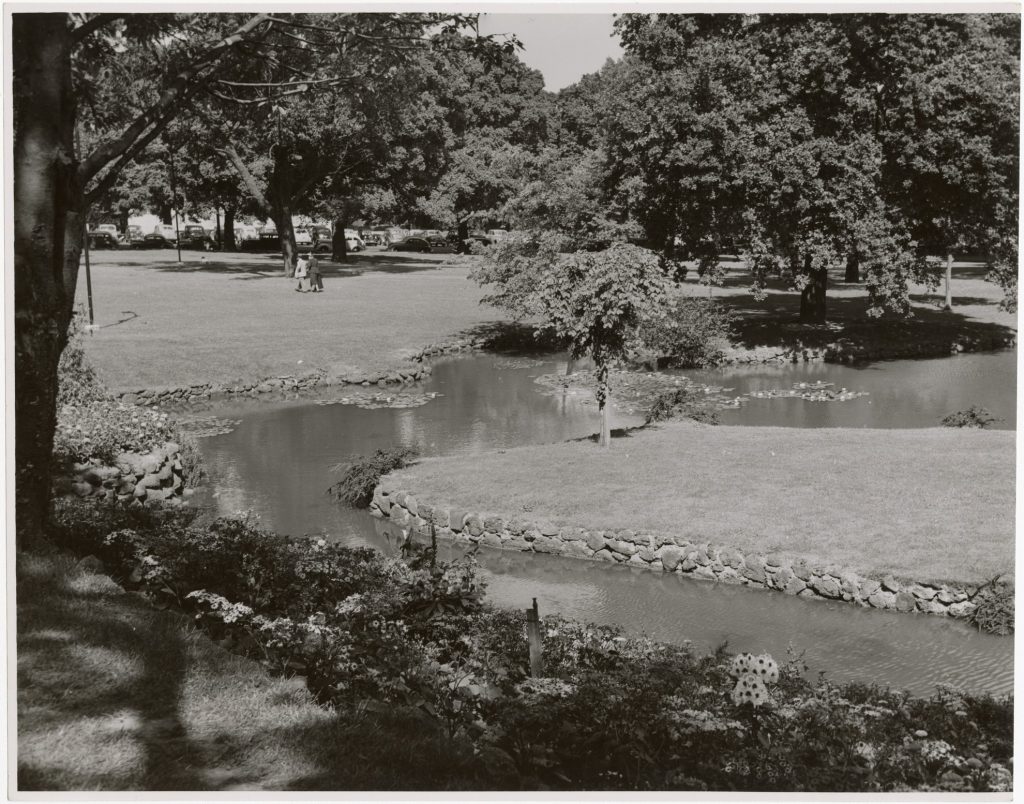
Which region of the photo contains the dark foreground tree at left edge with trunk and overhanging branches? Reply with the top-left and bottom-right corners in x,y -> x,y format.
11,12 -> 513,543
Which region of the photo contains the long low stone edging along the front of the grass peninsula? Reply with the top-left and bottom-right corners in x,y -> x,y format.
370,485 -> 978,618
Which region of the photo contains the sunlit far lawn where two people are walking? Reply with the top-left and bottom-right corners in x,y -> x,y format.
76,250 -> 507,390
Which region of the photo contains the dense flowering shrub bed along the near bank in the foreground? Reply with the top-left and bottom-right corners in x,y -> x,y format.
48,501 -> 1013,792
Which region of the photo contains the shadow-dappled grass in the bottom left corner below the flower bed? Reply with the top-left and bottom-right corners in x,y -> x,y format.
17,553 -> 495,791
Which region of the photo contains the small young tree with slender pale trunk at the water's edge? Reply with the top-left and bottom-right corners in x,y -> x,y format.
475,240 -> 671,447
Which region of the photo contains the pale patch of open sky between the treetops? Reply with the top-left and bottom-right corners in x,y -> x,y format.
480,13 -> 623,92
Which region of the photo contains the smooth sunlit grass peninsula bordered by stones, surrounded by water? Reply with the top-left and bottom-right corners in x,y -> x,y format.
385,422 -> 1015,583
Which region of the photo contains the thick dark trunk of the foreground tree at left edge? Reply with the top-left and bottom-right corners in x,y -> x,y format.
12,13 -> 84,546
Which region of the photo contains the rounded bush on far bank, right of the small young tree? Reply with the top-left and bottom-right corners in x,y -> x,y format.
636,296 -> 732,369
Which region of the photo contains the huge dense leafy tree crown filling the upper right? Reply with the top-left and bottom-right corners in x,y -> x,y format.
609,14 -> 1019,322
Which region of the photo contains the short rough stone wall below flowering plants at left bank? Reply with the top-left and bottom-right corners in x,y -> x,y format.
53,442 -> 193,508
